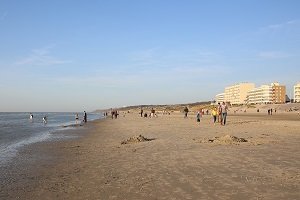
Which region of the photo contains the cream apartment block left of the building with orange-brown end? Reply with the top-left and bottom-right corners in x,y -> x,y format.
224,83 -> 255,105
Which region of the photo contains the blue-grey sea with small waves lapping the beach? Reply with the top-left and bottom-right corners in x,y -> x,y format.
0,112 -> 103,166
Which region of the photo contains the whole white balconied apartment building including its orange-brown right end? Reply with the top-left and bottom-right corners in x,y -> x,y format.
247,83 -> 286,104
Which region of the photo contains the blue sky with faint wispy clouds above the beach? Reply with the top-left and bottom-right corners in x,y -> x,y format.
0,0 -> 300,112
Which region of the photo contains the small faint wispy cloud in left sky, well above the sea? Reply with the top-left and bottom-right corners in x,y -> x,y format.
14,45 -> 71,66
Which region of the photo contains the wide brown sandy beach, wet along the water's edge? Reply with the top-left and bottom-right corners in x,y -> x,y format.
0,113 -> 300,199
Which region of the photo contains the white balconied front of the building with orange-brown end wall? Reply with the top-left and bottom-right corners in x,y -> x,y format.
247,85 -> 273,104
